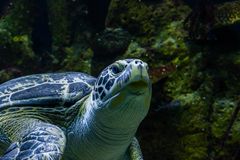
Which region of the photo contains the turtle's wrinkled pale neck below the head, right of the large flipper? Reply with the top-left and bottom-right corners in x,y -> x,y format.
63,97 -> 138,160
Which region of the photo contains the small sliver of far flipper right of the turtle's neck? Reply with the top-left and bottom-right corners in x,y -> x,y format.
129,137 -> 143,160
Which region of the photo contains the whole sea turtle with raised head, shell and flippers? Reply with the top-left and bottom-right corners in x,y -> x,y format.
0,59 -> 151,160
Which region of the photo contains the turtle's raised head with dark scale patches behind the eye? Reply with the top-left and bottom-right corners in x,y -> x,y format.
92,59 -> 151,128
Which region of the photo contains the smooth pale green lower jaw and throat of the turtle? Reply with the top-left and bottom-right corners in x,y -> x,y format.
95,74 -> 151,132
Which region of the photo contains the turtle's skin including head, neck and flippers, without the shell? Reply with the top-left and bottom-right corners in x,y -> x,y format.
0,59 -> 151,160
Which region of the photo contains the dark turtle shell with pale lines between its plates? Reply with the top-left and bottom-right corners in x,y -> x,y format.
0,72 -> 96,126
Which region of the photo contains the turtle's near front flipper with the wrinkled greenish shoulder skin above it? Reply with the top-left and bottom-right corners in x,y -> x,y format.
0,116 -> 66,160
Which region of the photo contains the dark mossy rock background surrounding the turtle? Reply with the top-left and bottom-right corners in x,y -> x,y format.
0,0 -> 240,160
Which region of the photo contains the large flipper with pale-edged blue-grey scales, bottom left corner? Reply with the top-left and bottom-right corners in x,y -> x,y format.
0,123 -> 66,160
